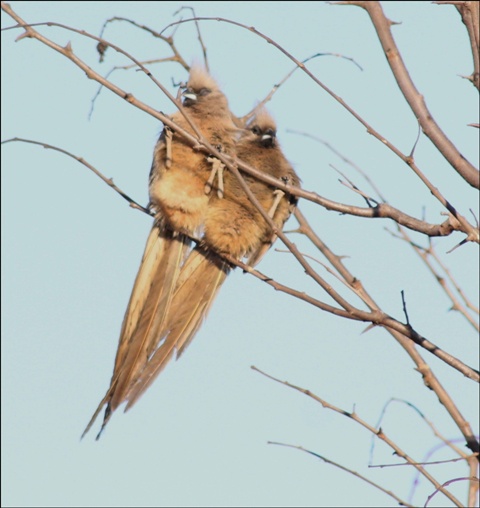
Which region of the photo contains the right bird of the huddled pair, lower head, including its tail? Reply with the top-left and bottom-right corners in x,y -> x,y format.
122,109 -> 300,407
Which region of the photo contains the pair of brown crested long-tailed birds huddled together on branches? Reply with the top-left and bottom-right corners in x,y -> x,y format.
82,66 -> 299,439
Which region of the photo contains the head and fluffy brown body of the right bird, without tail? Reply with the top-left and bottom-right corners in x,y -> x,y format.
205,108 -> 300,266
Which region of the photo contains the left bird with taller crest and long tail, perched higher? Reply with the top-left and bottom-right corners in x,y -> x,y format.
82,66 -> 239,439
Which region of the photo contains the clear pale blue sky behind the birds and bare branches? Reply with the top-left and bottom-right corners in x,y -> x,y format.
1,2 -> 479,507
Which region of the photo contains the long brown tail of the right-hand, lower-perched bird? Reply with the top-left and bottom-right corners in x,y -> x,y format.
125,248 -> 230,411
